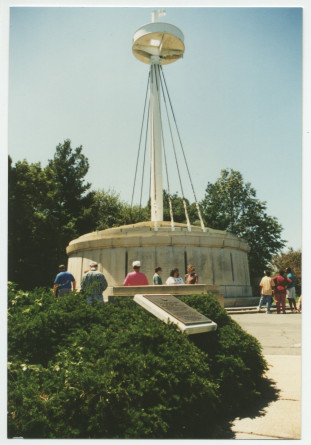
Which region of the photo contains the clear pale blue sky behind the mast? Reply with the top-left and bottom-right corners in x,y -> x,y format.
9,7 -> 302,249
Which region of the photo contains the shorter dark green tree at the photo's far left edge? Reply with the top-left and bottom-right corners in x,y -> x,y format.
8,158 -> 56,289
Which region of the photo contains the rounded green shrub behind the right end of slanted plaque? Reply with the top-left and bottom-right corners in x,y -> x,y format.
182,295 -> 267,413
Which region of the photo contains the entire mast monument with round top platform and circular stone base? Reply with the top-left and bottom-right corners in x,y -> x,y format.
67,11 -> 258,306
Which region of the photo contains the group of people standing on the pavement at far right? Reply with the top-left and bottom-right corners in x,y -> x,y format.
257,267 -> 301,314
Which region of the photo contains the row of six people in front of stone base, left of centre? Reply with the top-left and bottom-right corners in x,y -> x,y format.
53,261 -> 198,304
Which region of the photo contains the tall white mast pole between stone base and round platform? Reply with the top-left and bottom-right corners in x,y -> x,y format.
150,56 -> 163,222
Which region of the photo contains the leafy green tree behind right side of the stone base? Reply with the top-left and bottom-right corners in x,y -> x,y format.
200,169 -> 285,285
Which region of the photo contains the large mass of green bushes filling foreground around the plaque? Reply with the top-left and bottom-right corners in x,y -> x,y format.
8,285 -> 266,439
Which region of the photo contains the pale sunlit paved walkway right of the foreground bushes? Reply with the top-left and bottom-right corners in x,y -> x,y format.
231,312 -> 301,439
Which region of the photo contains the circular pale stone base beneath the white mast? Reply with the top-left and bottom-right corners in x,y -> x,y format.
67,221 -> 258,307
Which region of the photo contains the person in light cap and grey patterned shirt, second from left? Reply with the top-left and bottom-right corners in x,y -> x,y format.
81,261 -> 108,304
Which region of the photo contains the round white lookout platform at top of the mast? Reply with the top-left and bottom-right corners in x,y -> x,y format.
132,22 -> 185,65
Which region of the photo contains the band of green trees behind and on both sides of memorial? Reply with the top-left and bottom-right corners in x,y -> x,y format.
8,144 -> 284,289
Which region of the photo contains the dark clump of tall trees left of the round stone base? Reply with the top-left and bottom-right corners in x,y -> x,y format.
8,140 -> 95,289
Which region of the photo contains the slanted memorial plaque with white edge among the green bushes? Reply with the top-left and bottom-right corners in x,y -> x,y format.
134,294 -> 217,334
